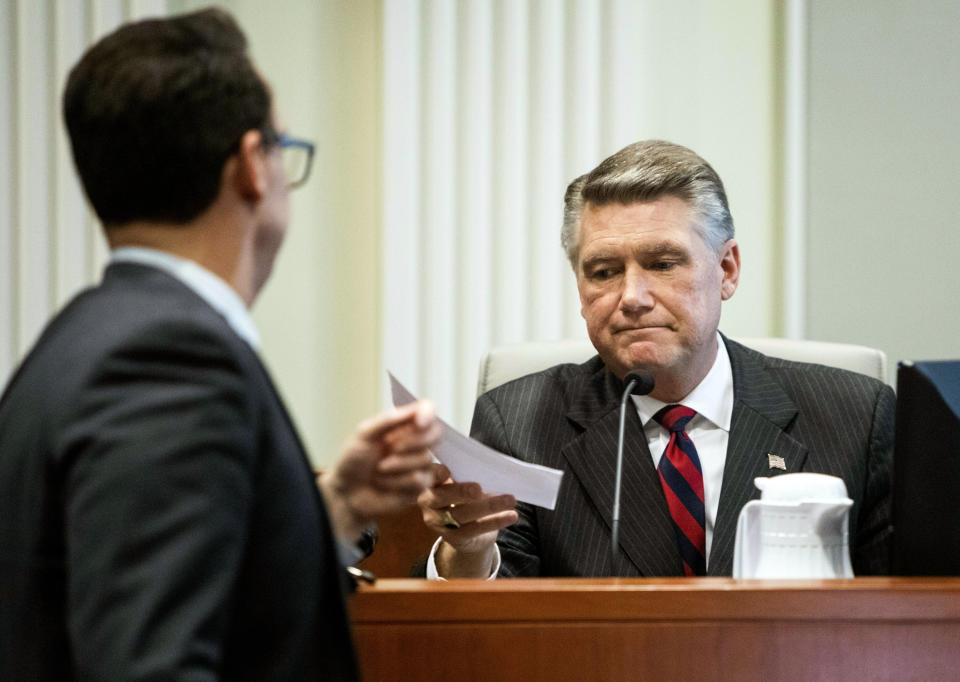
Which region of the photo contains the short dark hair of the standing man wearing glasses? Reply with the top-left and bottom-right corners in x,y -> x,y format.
63,9 -> 271,226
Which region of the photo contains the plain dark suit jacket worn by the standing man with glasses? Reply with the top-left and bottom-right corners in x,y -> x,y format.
0,263 -> 356,680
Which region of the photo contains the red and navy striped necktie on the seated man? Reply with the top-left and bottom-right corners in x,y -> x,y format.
653,405 -> 707,576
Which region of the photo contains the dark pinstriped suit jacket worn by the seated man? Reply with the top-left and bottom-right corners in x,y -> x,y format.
472,339 -> 894,576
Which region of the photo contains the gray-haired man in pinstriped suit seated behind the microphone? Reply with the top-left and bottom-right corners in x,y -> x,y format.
420,141 -> 894,577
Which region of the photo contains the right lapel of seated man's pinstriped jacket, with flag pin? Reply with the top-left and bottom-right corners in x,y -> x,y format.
708,337 -> 807,575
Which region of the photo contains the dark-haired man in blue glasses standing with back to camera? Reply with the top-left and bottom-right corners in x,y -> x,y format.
0,10 -> 439,680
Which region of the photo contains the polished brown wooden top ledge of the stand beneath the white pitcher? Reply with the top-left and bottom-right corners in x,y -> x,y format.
353,577 -> 960,623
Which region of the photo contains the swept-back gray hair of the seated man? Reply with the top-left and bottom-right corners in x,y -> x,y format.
560,140 -> 733,272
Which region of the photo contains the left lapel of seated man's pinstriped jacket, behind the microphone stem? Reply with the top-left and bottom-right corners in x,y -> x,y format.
562,365 -> 683,576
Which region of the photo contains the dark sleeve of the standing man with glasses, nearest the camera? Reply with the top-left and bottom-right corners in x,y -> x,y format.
58,325 -> 257,680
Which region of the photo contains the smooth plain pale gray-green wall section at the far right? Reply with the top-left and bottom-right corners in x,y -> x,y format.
806,0 -> 960,378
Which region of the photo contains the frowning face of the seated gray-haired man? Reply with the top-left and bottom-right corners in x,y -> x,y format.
577,196 -> 740,400
